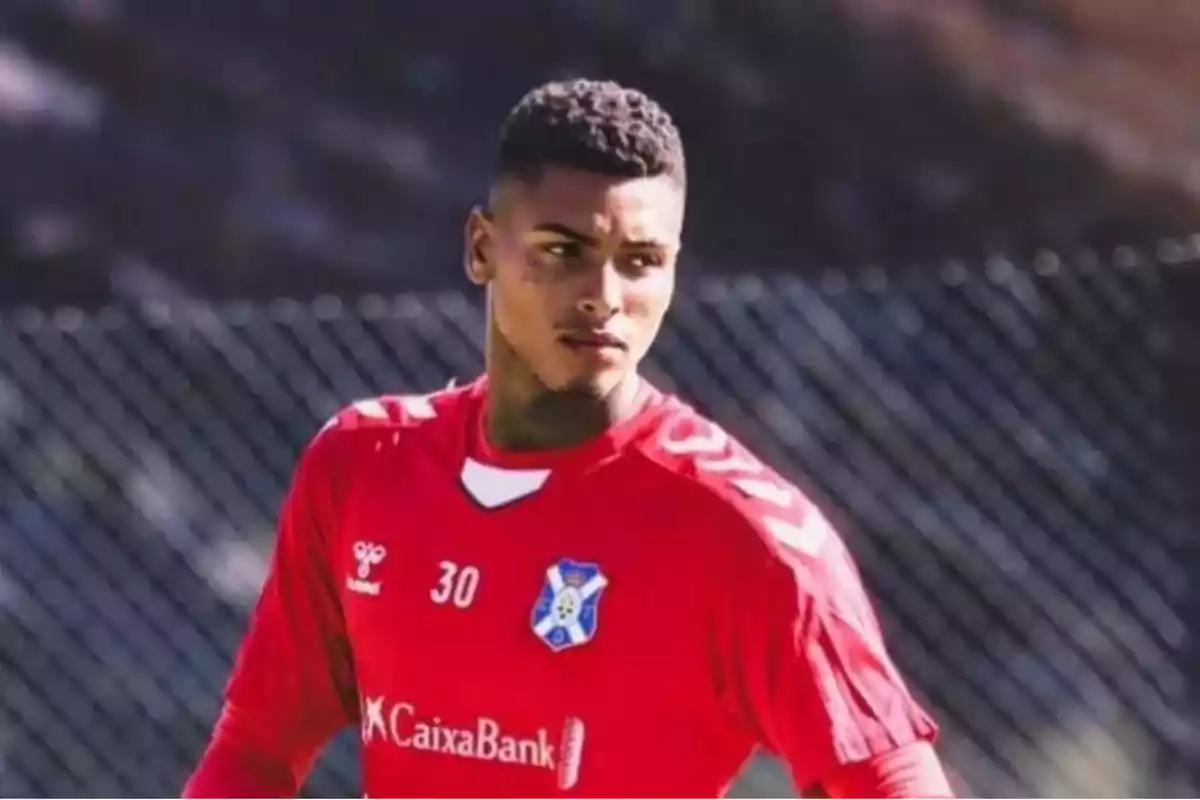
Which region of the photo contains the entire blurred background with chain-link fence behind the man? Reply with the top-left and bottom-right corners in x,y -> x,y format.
0,0 -> 1200,796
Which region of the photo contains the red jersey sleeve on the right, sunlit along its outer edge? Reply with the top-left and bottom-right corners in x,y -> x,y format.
705,487 -> 937,796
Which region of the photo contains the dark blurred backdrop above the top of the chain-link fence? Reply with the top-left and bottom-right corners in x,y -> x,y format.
0,0 -> 1200,305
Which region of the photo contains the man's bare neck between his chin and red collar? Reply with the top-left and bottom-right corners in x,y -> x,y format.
485,331 -> 641,451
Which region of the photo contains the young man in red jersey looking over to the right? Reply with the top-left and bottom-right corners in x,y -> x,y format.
185,80 -> 949,796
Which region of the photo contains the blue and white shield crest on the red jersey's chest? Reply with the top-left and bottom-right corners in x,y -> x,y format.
533,559 -> 608,652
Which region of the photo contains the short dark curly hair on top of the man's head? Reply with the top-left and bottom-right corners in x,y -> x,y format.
498,78 -> 686,185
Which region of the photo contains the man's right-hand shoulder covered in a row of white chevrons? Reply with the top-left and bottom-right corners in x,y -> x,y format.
641,401 -> 834,558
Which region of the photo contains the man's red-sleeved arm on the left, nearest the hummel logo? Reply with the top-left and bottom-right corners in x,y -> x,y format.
182,432 -> 358,798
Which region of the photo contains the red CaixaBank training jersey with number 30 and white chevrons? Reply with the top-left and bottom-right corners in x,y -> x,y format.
189,379 -> 935,796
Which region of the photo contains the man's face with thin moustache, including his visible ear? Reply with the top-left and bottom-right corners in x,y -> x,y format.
467,168 -> 684,395
